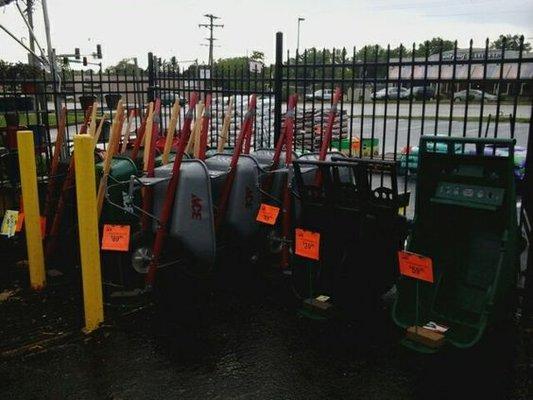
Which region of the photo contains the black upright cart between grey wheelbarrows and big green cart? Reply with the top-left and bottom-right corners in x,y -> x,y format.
292,156 -> 409,319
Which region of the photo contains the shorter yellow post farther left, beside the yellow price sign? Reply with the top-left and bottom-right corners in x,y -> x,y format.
17,131 -> 46,290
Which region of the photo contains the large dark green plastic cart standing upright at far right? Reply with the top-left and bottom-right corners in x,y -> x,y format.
392,136 -> 519,353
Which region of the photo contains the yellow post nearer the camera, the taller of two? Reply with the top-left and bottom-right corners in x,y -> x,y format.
74,134 -> 104,333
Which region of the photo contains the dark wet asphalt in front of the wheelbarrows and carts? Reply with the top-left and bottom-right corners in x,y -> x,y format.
0,260 -> 531,400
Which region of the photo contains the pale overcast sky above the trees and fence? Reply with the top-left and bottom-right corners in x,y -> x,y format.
0,0 -> 533,67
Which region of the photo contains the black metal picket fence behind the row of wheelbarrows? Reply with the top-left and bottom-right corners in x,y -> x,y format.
0,34 -> 533,195
